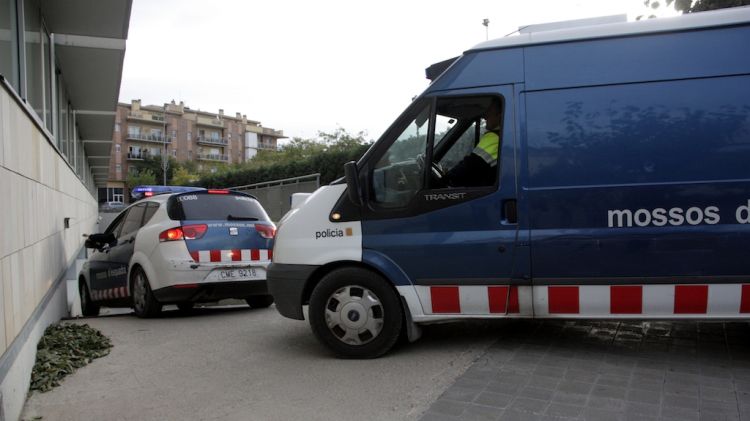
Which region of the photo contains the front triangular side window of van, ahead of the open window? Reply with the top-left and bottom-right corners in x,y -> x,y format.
372,104 -> 430,207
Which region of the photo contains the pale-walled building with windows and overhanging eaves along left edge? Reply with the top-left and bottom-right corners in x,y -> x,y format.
0,0 -> 132,420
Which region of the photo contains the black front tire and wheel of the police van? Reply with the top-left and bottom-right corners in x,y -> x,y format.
308,267 -> 404,358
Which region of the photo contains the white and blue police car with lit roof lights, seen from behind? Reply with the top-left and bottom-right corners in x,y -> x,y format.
78,190 -> 276,317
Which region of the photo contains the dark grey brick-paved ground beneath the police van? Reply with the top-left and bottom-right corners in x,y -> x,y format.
422,321 -> 750,421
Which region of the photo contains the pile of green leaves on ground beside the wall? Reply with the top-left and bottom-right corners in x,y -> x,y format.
30,323 -> 112,392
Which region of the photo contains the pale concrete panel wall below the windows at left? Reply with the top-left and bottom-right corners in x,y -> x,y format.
0,85 -> 98,419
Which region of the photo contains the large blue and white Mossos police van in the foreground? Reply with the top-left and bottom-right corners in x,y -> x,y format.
268,7 -> 750,357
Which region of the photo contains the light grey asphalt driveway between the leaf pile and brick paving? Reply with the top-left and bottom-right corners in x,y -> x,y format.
23,307 -> 504,421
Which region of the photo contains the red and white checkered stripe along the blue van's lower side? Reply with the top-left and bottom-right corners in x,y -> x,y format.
415,284 -> 750,318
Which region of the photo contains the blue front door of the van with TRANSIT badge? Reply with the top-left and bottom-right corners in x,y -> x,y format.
362,86 -> 532,316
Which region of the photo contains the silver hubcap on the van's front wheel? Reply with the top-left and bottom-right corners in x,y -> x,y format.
325,285 -> 383,345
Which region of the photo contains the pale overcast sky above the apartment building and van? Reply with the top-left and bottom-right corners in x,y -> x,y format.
120,0 -> 680,139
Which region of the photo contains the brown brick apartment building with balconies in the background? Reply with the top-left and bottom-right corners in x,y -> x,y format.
99,100 -> 284,202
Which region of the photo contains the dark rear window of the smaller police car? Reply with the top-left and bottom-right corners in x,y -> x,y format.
167,193 -> 269,221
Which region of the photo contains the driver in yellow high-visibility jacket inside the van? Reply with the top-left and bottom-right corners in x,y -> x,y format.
446,99 -> 501,187
